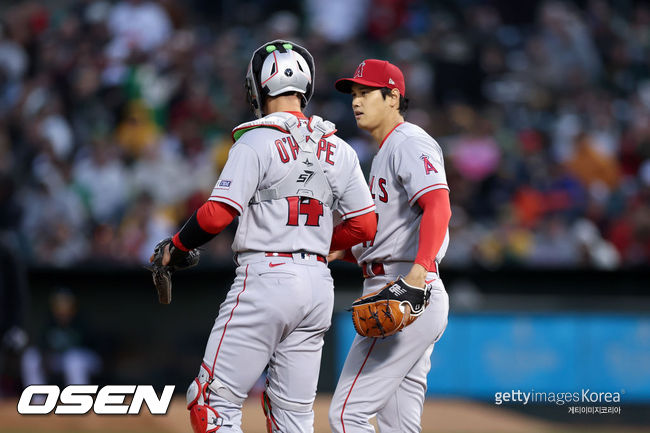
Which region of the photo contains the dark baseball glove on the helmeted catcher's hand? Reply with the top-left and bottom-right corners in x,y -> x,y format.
147,238 -> 200,304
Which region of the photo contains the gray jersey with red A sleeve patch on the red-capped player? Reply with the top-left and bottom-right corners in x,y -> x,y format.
352,122 -> 449,263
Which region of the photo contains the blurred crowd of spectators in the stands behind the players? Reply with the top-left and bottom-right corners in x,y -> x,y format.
0,0 -> 650,269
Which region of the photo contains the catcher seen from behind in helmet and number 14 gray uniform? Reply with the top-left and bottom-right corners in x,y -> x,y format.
156,40 -> 376,433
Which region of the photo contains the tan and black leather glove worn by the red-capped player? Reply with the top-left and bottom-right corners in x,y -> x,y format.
351,277 -> 431,337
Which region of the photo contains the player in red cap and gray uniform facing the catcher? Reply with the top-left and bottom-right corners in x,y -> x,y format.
329,59 -> 451,433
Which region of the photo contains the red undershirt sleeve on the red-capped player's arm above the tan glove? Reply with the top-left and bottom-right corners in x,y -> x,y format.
415,188 -> 451,270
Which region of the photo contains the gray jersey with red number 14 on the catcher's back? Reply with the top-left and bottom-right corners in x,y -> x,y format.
210,122 -> 374,255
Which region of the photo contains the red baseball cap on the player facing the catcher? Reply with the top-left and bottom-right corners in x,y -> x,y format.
334,59 -> 406,96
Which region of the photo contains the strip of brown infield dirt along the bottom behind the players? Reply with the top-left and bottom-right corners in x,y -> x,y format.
0,395 -> 650,433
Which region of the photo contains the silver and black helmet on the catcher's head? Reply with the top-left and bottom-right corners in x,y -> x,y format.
246,39 -> 314,118
